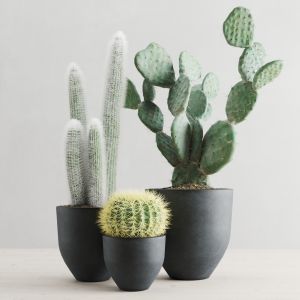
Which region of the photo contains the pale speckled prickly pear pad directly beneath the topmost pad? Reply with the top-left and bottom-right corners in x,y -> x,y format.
239,43 -> 266,81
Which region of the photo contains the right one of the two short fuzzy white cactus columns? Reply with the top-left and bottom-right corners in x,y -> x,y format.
88,119 -> 106,207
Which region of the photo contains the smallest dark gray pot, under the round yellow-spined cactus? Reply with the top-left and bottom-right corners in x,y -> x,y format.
103,236 -> 166,291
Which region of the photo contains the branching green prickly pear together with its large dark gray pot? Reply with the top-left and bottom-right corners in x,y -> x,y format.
125,7 -> 282,280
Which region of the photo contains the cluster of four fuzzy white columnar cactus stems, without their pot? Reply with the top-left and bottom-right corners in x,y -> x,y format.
66,33 -> 126,207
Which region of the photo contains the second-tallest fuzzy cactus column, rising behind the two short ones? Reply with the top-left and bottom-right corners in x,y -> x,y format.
68,63 -> 87,128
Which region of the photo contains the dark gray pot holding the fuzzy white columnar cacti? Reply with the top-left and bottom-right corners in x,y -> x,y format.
56,206 -> 110,282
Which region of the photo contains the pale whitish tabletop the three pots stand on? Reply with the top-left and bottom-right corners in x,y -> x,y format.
0,249 -> 300,300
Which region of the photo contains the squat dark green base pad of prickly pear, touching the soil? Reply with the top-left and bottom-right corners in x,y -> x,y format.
172,163 -> 206,187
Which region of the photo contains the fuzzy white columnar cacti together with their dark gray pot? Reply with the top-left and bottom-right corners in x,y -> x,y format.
56,33 -> 126,281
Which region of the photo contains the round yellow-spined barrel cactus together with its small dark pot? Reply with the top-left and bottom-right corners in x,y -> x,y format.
99,192 -> 169,291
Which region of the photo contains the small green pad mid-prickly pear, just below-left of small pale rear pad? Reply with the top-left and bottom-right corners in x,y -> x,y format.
186,88 -> 207,118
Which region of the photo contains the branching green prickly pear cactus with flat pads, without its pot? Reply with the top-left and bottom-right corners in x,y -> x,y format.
125,7 -> 282,188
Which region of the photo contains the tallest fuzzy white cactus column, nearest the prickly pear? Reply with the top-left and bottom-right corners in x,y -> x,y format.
103,32 -> 127,197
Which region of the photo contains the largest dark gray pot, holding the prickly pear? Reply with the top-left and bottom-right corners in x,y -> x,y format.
154,189 -> 233,280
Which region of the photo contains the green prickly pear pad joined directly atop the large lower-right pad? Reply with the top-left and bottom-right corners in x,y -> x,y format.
226,81 -> 257,123
